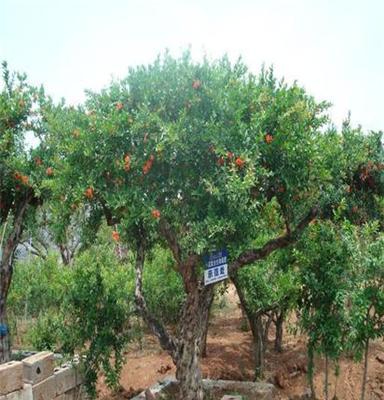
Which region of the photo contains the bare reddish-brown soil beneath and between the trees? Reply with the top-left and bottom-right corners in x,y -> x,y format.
98,288 -> 384,400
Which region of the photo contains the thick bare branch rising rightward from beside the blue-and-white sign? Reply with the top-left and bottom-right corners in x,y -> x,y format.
229,207 -> 319,275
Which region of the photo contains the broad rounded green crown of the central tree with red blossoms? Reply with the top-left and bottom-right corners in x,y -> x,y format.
45,53 -> 338,256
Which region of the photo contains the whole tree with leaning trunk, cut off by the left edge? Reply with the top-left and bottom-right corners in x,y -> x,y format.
0,62 -> 45,363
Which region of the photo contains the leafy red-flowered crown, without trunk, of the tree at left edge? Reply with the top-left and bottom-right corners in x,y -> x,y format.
0,62 -> 45,228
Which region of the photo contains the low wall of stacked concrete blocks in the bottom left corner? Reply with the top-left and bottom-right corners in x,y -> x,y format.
0,351 -> 87,400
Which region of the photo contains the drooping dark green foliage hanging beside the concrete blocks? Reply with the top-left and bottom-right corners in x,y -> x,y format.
63,248 -> 134,395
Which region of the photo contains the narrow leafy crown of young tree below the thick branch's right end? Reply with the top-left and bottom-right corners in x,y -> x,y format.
295,221 -> 355,360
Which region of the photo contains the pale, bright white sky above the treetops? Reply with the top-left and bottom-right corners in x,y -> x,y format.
0,0 -> 384,130
